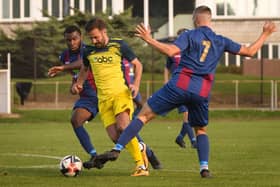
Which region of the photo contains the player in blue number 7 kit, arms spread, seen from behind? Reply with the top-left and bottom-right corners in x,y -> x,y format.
96,6 -> 276,178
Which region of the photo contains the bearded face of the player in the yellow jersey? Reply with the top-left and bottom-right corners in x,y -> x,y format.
88,28 -> 108,48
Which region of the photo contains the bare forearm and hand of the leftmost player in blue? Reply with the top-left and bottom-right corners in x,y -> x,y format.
48,59 -> 82,77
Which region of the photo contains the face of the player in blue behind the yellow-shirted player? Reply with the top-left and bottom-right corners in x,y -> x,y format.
64,31 -> 82,51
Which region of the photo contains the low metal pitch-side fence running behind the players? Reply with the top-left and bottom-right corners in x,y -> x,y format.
11,80 -> 280,110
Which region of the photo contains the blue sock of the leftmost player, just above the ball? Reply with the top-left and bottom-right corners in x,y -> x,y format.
74,126 -> 96,156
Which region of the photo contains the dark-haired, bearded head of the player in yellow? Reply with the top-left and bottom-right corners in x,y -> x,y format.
85,18 -> 109,48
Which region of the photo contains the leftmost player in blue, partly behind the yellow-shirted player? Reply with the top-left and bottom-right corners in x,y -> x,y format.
48,25 -> 103,169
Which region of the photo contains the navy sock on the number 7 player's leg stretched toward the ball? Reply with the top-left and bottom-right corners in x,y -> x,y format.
113,118 -> 144,151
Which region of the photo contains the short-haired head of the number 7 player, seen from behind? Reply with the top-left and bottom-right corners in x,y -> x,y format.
193,5 -> 212,27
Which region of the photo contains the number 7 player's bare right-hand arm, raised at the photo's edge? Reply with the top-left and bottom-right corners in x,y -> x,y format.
238,21 -> 277,57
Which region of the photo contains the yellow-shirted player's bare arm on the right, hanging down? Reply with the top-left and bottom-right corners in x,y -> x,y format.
129,58 -> 143,97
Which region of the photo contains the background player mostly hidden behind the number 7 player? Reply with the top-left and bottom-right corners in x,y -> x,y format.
164,28 -> 196,148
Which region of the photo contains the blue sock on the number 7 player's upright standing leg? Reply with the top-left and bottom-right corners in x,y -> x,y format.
196,134 -> 209,170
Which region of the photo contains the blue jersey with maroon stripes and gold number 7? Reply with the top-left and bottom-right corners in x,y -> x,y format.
171,26 -> 240,98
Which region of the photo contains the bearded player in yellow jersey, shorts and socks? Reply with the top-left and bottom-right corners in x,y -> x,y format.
72,18 -> 149,176
